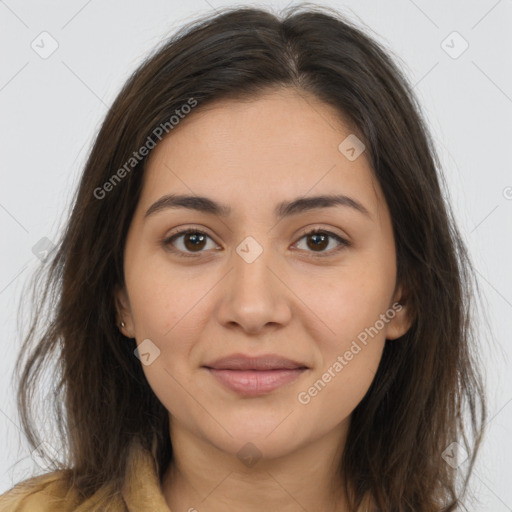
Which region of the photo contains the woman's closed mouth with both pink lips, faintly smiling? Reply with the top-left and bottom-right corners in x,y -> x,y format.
203,354 -> 309,396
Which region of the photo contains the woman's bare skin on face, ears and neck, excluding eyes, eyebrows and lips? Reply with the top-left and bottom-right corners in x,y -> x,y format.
116,89 -> 410,512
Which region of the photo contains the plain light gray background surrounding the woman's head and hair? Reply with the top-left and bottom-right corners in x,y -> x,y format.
0,0 -> 512,512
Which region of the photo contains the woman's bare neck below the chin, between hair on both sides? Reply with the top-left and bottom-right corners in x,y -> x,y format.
162,421 -> 348,512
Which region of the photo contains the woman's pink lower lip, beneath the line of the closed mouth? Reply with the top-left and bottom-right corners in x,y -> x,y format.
207,368 -> 306,396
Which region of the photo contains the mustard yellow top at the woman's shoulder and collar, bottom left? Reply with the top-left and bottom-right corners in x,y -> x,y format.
0,440 -> 171,512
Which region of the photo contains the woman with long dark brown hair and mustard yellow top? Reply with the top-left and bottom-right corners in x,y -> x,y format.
0,6 -> 485,512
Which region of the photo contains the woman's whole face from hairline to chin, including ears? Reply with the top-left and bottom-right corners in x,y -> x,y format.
118,89 -> 408,458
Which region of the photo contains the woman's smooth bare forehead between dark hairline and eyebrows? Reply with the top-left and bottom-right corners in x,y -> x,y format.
141,89 -> 382,218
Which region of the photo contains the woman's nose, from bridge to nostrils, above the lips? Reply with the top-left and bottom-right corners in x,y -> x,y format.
217,240 -> 293,334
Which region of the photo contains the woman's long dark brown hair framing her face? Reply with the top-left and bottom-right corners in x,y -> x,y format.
10,4 -> 486,512
